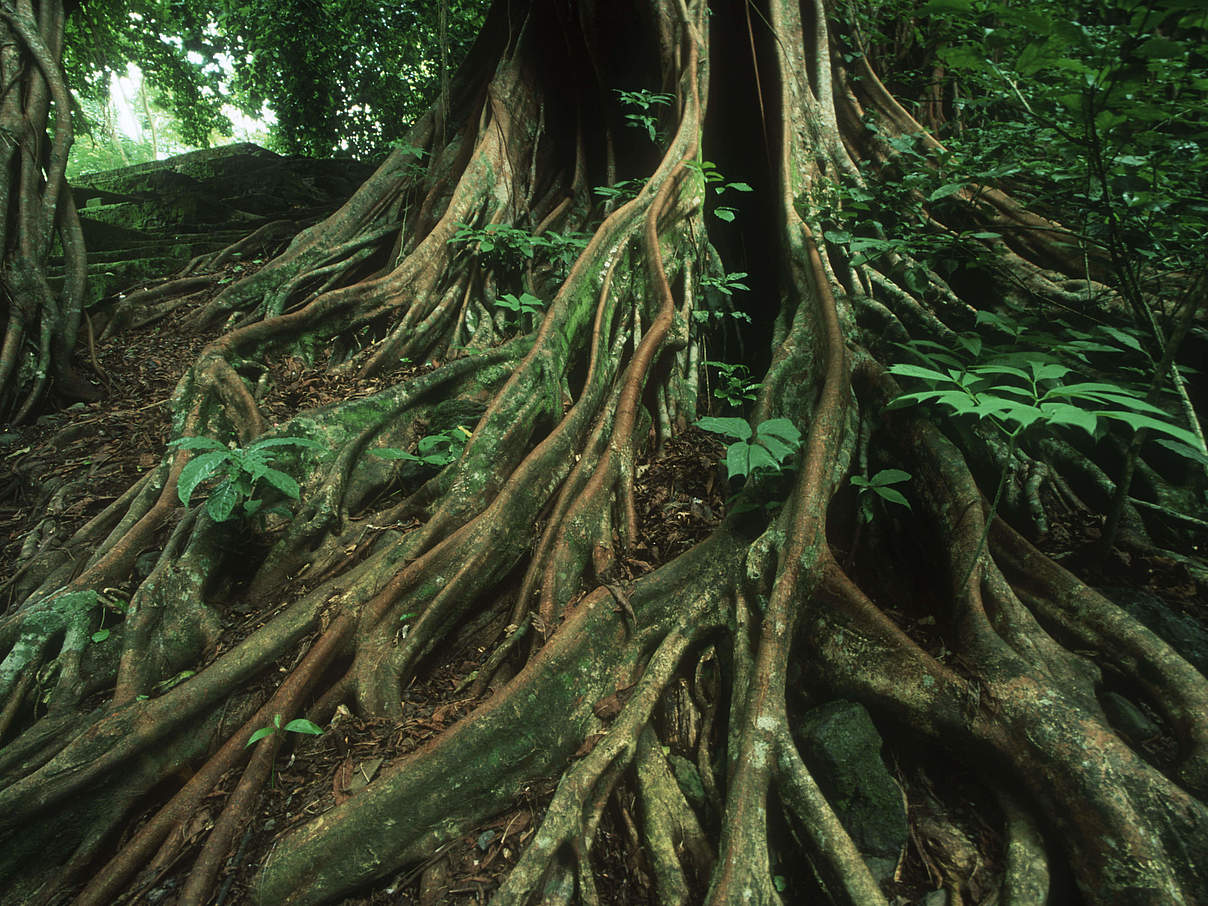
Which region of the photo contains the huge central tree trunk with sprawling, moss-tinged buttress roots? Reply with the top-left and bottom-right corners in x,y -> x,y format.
0,0 -> 1208,906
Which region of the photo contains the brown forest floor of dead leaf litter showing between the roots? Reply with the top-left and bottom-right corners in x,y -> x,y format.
0,237 -> 1208,906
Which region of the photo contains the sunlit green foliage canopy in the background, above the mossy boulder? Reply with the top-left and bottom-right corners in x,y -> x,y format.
64,0 -> 486,157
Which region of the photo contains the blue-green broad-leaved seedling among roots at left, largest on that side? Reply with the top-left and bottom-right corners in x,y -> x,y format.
168,437 -> 323,522
